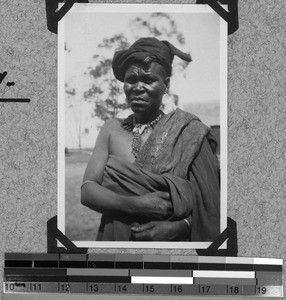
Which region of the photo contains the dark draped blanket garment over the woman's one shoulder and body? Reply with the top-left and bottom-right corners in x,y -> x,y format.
97,109 -> 220,241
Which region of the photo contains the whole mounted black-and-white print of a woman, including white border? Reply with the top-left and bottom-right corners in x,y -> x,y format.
58,3 -> 227,249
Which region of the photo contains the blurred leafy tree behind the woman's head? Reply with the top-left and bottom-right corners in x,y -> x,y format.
84,13 -> 187,121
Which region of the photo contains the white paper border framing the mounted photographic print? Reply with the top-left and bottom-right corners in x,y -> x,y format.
57,3 -> 227,249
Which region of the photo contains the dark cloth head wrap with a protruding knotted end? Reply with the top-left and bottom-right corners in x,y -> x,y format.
112,37 -> 192,82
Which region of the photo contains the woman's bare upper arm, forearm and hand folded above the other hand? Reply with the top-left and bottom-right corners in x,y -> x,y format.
81,120 -> 172,220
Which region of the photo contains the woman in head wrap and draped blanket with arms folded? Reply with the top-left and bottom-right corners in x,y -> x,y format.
81,38 -> 220,241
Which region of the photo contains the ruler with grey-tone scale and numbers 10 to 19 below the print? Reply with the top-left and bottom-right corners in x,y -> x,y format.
3,253 -> 283,297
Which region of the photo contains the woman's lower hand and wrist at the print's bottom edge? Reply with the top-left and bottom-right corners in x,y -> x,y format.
131,220 -> 190,241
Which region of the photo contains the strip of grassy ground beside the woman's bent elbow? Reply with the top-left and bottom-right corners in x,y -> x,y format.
65,150 -> 101,241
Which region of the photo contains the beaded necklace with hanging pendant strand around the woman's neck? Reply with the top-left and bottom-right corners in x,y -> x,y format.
121,111 -> 164,158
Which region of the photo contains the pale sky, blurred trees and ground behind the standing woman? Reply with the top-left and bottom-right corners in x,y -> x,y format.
62,10 -> 221,241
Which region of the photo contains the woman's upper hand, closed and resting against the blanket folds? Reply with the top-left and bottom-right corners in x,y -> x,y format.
136,192 -> 173,220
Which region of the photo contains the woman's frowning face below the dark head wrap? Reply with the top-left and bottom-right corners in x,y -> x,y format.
123,62 -> 169,114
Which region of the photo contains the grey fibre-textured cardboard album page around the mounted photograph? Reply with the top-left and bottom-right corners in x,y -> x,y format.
0,0 -> 286,298
